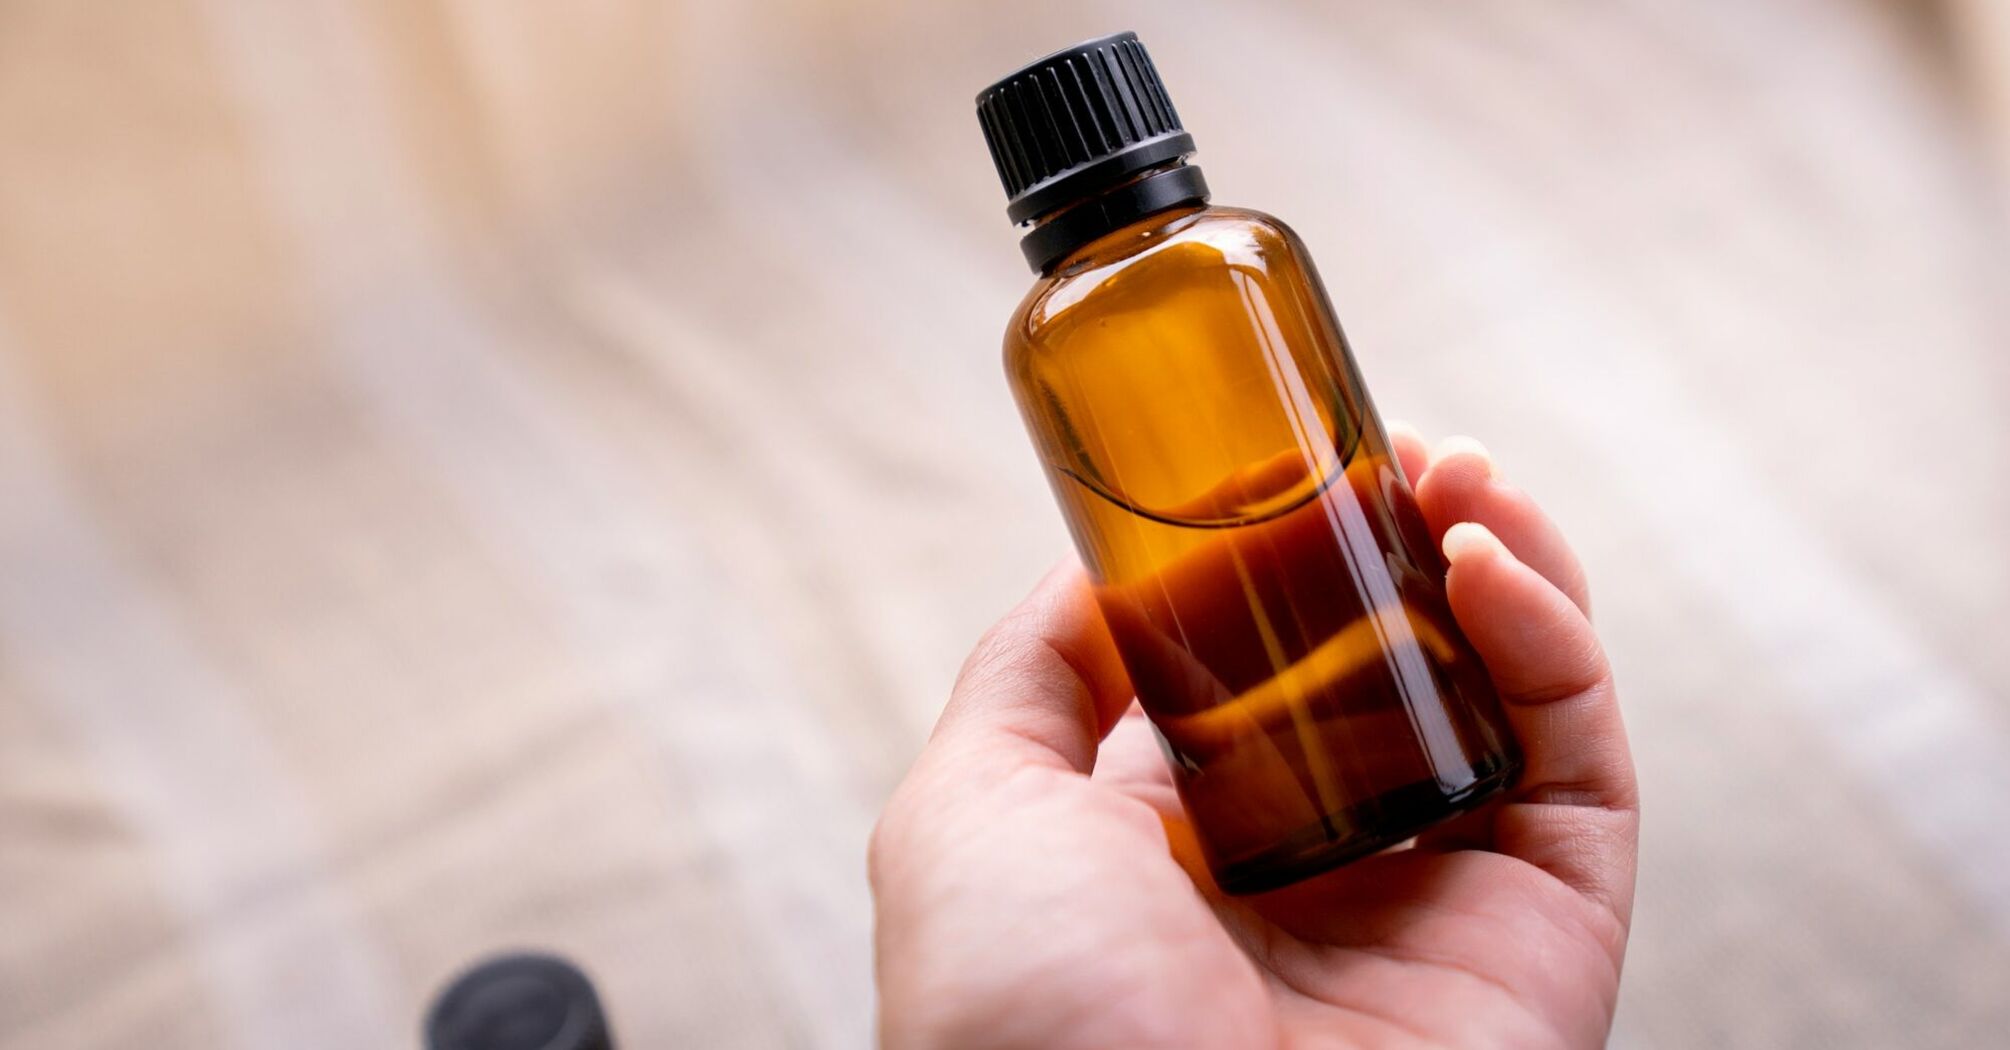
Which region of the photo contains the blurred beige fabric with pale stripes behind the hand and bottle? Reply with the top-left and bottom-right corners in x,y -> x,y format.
0,0 -> 2010,1050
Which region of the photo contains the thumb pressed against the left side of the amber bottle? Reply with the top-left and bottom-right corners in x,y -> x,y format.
929,559 -> 1130,776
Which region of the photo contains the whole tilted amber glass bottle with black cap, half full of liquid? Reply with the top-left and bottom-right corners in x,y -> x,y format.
977,32 -> 1520,893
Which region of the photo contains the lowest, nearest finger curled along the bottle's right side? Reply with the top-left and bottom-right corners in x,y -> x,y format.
1433,522 -> 1638,919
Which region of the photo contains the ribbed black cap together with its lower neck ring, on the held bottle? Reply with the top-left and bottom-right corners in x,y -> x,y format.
977,32 -> 1208,272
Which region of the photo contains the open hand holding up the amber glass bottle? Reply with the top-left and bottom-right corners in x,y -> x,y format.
870,430 -> 1640,1048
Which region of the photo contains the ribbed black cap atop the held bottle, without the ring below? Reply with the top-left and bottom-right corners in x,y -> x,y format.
977,32 -> 1194,223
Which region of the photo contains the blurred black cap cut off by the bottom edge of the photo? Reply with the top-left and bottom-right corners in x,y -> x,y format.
426,953 -> 615,1050
